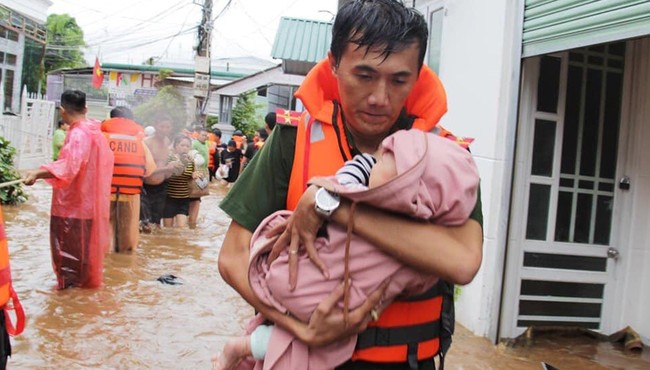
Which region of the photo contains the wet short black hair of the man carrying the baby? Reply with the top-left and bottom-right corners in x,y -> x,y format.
330,0 -> 429,69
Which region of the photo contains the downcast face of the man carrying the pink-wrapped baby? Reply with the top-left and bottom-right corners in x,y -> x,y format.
328,43 -> 419,138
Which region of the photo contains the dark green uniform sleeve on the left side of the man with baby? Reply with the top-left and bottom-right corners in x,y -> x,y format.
219,125 -> 297,232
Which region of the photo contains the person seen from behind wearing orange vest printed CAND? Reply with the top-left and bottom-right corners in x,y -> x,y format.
101,107 -> 156,253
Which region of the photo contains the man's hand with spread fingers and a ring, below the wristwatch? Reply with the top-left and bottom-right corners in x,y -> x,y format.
268,185 -> 329,290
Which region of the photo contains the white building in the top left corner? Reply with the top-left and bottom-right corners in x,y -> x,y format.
0,0 -> 52,112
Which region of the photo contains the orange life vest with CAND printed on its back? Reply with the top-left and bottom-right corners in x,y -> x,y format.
102,117 -> 146,194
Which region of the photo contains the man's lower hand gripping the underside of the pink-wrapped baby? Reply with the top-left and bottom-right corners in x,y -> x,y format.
296,278 -> 390,347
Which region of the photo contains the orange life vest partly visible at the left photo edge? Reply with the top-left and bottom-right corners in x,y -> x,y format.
0,204 -> 25,336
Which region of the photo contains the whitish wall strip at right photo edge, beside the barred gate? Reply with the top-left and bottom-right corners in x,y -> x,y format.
612,37 -> 650,345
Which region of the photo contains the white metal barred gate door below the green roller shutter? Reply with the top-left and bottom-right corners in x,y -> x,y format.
501,42 -> 625,337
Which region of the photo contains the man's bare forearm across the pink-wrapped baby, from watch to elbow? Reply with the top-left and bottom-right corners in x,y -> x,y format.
332,201 -> 483,284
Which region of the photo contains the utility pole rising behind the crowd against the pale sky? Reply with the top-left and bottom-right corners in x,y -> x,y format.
194,0 -> 212,123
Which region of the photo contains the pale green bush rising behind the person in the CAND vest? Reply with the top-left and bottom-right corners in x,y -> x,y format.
133,85 -> 187,131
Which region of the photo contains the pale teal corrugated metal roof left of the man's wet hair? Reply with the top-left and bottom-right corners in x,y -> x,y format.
271,17 -> 332,63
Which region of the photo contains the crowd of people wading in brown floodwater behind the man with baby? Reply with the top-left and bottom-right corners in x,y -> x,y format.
24,90 -> 275,289
